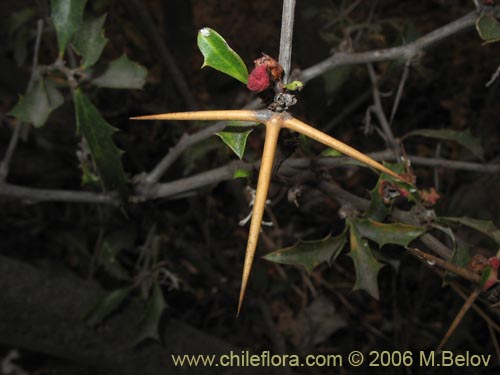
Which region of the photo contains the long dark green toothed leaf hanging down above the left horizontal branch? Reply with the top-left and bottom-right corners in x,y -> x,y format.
73,89 -> 127,195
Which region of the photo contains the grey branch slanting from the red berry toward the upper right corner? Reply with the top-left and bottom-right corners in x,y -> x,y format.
302,12 -> 477,83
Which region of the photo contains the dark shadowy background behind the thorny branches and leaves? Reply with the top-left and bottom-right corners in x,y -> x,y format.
0,0 -> 500,374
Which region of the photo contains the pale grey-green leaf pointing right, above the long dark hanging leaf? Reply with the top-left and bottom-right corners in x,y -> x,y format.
92,55 -> 148,89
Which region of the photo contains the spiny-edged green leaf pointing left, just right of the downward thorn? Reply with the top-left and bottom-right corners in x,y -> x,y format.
264,231 -> 346,273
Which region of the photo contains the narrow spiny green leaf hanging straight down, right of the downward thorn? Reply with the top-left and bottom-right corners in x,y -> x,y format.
348,224 -> 384,300
